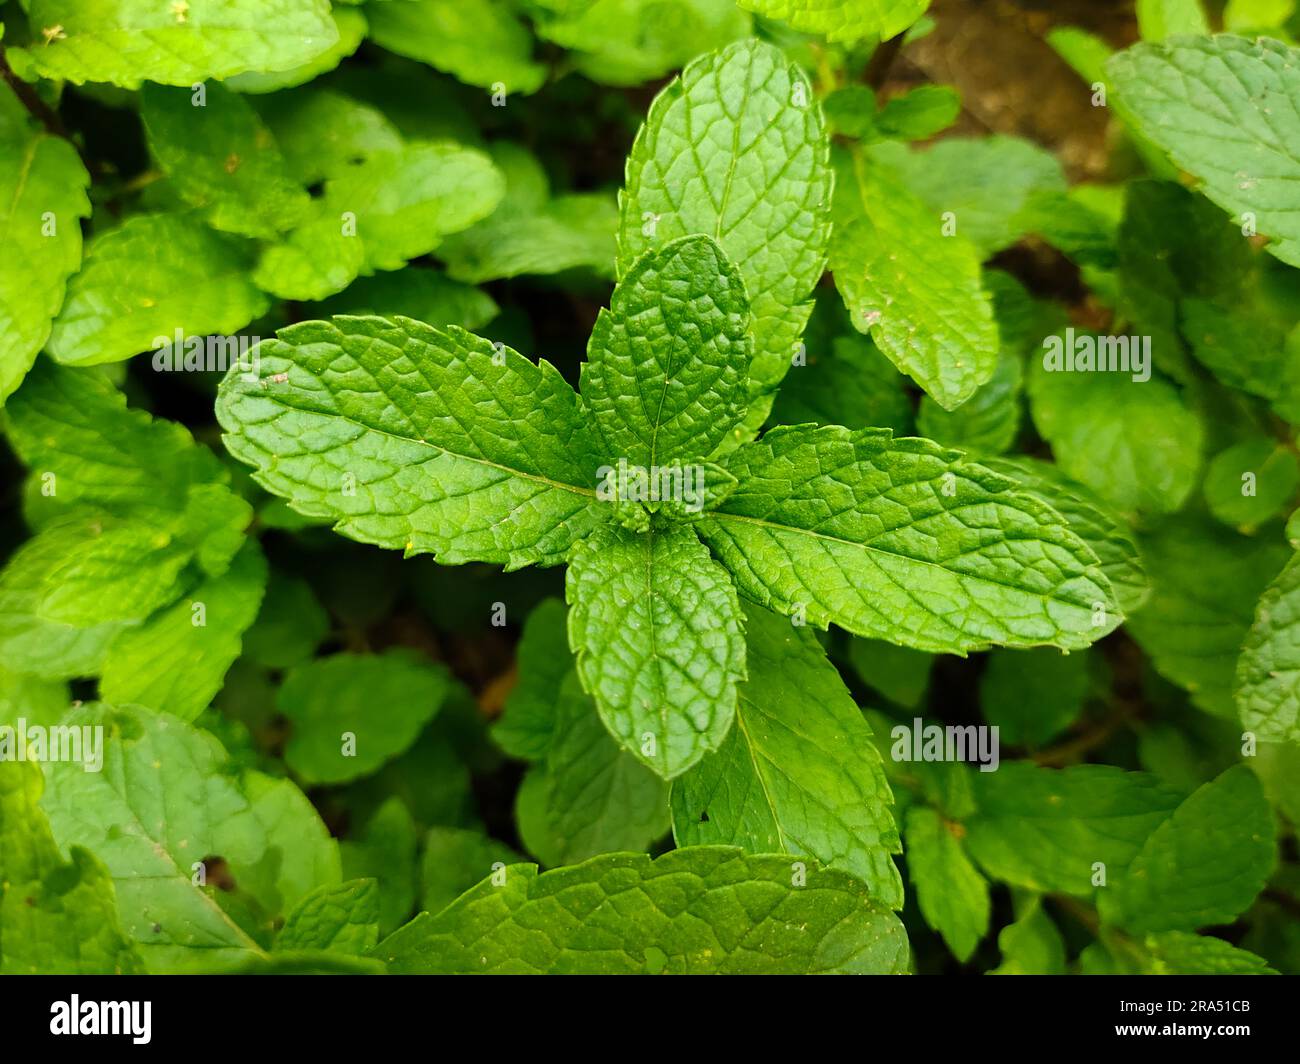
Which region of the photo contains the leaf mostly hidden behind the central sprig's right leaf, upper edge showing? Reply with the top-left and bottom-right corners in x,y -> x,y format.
983,455 -> 1151,614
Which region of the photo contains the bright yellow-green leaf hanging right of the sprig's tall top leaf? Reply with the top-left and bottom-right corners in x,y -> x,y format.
828,152 -> 998,410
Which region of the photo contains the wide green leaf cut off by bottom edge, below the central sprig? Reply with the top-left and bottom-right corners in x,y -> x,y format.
373,847 -> 907,974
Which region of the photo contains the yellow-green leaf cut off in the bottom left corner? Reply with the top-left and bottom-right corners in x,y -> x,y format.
0,758 -> 144,976
